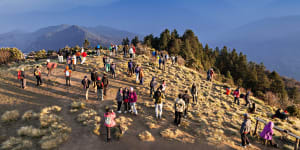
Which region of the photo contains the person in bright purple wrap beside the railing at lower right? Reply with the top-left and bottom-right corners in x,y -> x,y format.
260,121 -> 278,147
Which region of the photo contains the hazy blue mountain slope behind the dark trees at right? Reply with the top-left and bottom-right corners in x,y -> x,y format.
209,16 -> 300,80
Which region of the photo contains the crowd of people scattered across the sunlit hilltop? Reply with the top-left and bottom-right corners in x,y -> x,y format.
18,45 -> 287,147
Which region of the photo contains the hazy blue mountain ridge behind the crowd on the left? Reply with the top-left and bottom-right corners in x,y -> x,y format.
0,24 -> 136,52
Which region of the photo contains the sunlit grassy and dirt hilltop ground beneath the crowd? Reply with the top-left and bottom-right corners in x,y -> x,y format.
0,52 -> 300,150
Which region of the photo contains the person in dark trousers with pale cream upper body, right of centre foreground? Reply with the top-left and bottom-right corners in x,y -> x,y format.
174,94 -> 185,126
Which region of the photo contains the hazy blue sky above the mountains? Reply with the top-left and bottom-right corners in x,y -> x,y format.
0,0 -> 300,41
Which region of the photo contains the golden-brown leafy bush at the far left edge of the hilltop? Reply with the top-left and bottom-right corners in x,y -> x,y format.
0,48 -> 23,64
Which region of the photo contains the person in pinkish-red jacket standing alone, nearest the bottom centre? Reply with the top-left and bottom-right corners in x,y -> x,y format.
104,108 -> 123,142
